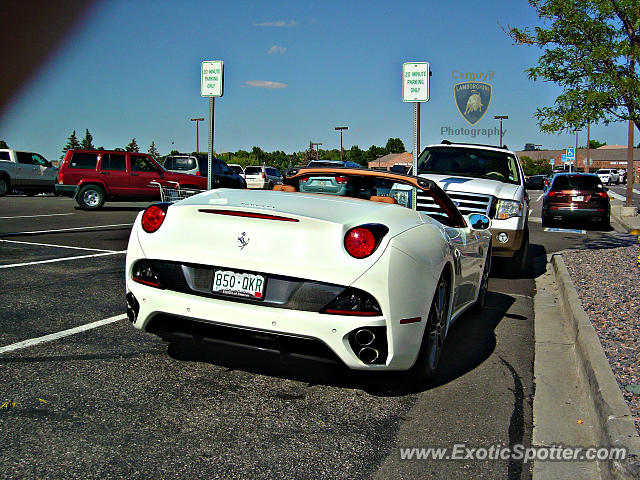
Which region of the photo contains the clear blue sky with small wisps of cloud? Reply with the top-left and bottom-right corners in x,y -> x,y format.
0,0 -> 637,160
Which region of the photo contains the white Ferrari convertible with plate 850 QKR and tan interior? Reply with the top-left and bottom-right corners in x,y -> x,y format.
126,167 -> 491,381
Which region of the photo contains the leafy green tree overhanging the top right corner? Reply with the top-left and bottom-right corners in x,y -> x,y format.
508,0 -> 640,132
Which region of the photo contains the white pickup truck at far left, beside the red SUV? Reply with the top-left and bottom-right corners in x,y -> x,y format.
0,148 -> 58,197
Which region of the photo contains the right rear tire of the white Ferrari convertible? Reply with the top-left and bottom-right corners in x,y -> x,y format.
407,274 -> 450,385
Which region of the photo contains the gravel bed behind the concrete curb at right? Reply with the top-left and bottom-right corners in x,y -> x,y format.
563,244 -> 640,432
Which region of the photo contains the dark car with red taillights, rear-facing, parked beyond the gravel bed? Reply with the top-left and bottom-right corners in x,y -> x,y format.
542,173 -> 611,228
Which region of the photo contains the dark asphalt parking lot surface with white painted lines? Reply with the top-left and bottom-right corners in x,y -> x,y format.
0,192 -> 616,479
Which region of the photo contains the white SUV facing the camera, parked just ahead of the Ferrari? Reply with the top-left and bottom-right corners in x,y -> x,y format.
416,140 -> 529,269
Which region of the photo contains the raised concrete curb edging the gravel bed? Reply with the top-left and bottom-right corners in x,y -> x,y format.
551,255 -> 640,480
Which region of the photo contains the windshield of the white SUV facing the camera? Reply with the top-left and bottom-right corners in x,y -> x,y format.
418,147 -> 520,185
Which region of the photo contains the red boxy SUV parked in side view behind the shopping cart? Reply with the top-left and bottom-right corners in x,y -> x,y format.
55,150 -> 207,210
